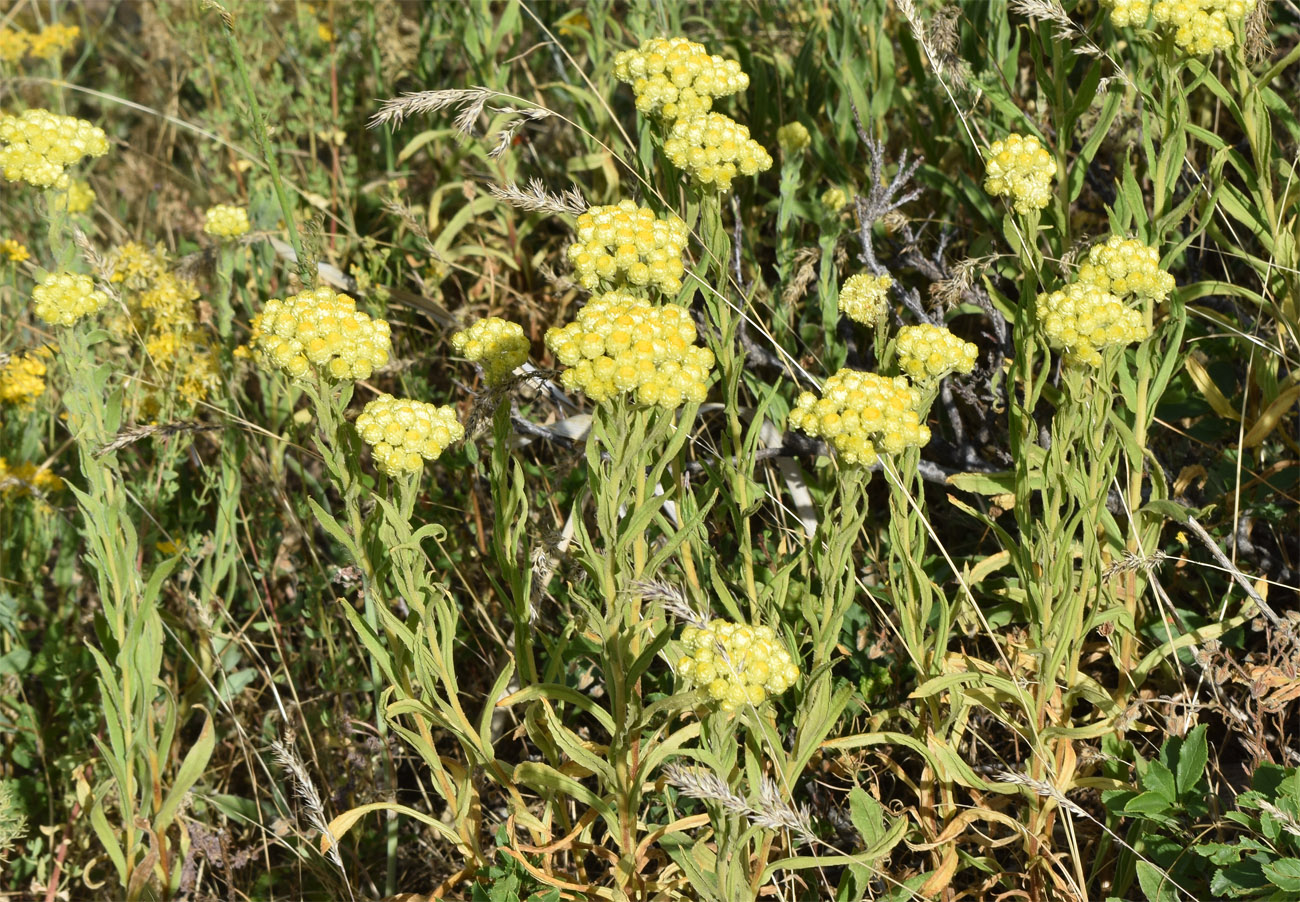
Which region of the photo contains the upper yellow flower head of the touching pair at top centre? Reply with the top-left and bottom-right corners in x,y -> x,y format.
614,38 -> 749,121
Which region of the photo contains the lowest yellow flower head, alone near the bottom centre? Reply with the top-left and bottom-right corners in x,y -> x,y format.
677,620 -> 800,714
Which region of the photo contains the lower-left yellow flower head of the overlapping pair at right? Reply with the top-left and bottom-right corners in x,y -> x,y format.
1035,282 -> 1151,367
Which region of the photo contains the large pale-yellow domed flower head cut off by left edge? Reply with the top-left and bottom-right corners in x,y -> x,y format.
0,109 -> 108,188
